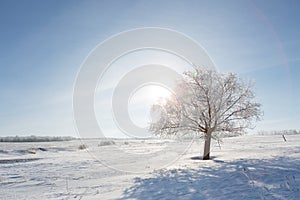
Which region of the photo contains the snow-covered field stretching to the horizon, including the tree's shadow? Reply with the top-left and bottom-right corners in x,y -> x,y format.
0,135 -> 300,200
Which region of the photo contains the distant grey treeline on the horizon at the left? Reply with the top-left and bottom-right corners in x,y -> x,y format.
0,135 -> 75,142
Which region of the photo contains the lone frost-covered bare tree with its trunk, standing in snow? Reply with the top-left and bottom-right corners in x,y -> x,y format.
150,66 -> 261,160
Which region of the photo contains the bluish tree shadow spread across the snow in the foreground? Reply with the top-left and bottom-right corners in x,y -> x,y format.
123,157 -> 300,200
